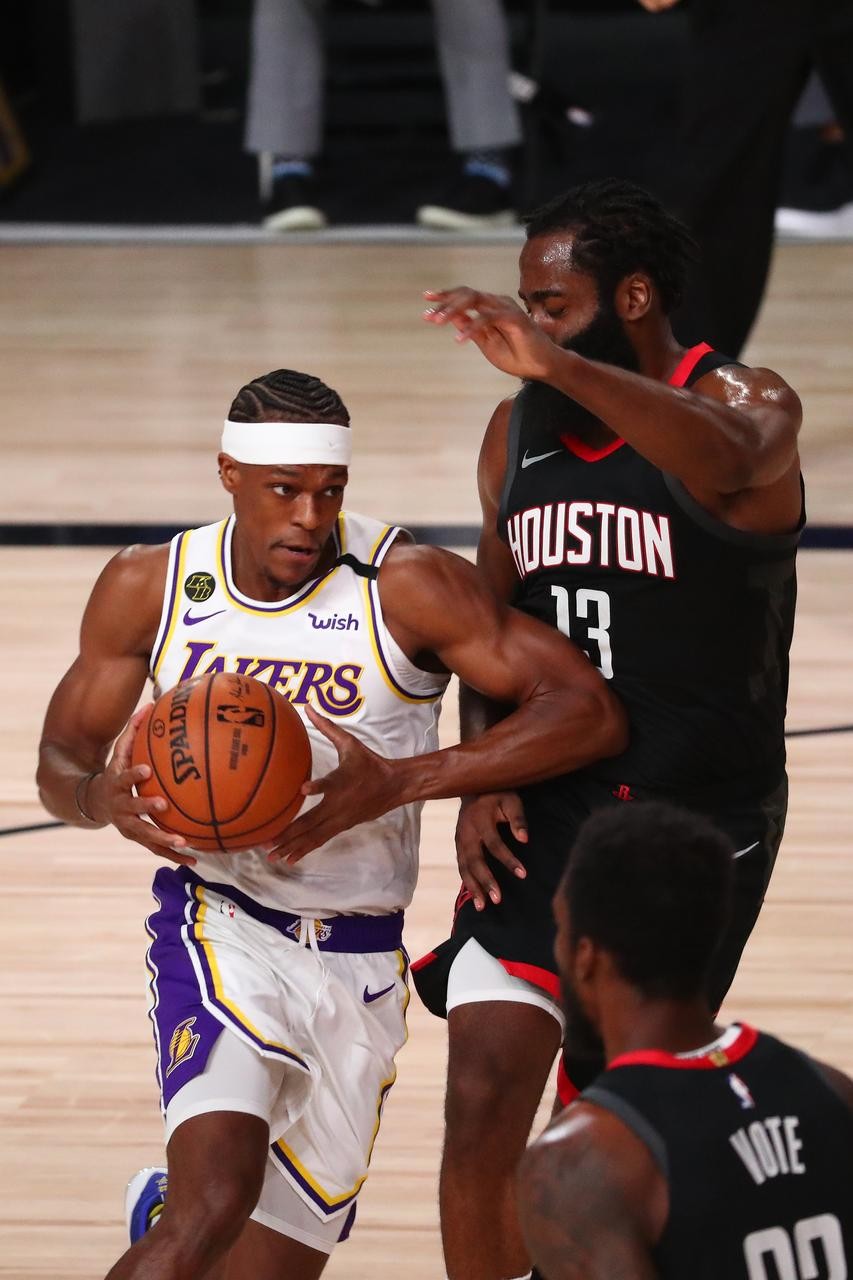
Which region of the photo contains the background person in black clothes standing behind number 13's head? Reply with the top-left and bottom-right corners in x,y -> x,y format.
639,0 -> 853,356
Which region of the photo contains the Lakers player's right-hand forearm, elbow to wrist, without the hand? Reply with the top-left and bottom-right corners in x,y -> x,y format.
393,691 -> 628,804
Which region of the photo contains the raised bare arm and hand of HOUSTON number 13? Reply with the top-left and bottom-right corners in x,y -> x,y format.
428,289 -> 802,532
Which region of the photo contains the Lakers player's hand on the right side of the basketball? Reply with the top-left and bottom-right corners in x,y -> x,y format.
266,707 -> 401,864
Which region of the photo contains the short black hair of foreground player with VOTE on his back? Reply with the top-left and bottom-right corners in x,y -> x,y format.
561,803 -> 734,1000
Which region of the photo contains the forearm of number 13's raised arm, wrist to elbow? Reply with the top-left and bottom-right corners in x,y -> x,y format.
543,348 -> 766,493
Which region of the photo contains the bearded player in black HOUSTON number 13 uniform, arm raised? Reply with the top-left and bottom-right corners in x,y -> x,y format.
412,179 -> 804,1280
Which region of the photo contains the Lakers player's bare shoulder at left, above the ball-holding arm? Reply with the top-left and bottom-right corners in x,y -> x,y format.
83,543 -> 169,653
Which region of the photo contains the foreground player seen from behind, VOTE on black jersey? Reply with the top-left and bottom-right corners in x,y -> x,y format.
517,804 -> 853,1280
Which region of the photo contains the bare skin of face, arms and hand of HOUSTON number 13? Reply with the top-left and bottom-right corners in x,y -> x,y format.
424,232 -> 802,873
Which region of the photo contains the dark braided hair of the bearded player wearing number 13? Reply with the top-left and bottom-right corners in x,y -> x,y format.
524,178 -> 698,314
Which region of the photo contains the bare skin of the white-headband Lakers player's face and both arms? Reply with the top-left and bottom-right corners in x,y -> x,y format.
38,454 -> 626,899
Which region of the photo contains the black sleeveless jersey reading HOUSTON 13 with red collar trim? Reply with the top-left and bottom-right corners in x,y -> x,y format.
498,346 -> 804,803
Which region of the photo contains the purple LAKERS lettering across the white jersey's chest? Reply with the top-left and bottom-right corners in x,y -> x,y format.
177,640 -> 364,717
